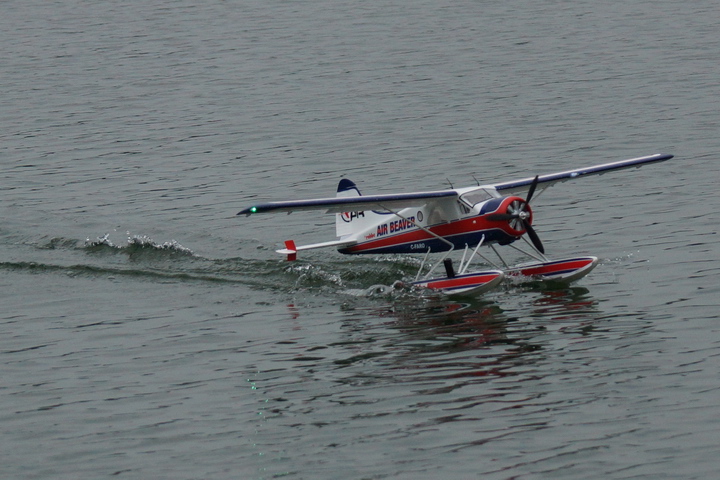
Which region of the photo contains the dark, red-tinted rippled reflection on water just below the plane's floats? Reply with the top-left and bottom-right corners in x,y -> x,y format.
336,286 -> 597,381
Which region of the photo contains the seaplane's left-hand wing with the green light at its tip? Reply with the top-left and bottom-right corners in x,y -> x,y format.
238,190 -> 458,215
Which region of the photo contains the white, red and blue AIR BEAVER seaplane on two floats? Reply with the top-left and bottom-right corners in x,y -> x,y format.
237,153 -> 673,295
